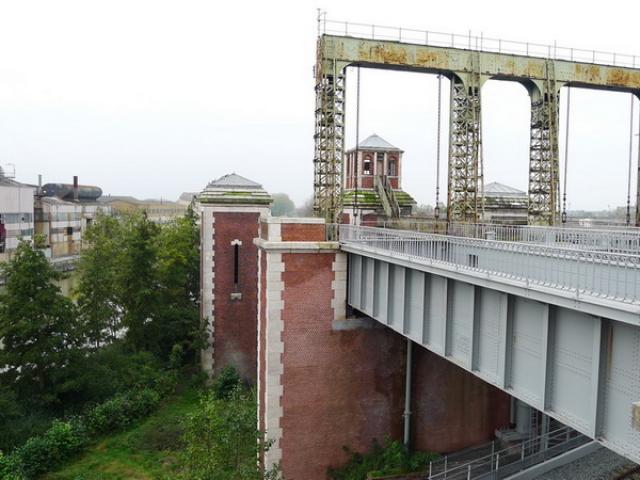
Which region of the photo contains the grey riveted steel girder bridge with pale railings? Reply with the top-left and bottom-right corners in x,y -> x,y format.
339,224 -> 640,463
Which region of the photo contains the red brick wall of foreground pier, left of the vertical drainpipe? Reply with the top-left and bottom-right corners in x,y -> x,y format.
280,254 -> 404,480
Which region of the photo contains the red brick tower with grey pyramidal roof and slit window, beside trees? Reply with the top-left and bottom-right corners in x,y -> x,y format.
198,173 -> 272,383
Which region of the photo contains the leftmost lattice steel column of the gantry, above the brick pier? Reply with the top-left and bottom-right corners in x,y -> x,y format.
313,37 -> 345,223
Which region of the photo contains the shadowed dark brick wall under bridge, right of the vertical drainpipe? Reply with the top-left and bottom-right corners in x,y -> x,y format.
411,344 -> 510,453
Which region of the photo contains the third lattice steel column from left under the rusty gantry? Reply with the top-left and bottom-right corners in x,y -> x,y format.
528,60 -> 560,225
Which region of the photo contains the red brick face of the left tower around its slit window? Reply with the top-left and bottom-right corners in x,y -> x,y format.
213,212 -> 259,383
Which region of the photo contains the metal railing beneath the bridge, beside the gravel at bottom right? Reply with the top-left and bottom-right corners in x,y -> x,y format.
424,427 -> 590,480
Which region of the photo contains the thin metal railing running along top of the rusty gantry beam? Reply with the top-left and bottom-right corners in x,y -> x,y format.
318,14 -> 640,68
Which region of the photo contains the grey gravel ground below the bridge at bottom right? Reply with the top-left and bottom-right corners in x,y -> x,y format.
536,448 -> 629,480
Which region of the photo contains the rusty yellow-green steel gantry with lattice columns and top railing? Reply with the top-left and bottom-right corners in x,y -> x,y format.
314,17 -> 640,225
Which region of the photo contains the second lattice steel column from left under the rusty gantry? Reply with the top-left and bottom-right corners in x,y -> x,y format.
447,76 -> 480,223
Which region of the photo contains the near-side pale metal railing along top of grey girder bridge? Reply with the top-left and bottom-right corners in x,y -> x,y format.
339,225 -> 640,304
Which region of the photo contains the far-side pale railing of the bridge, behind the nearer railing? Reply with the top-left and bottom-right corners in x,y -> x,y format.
362,219 -> 640,255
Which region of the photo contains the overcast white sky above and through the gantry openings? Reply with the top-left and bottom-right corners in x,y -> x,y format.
0,0 -> 640,209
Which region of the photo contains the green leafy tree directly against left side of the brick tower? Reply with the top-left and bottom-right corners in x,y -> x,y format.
154,213 -> 201,357
